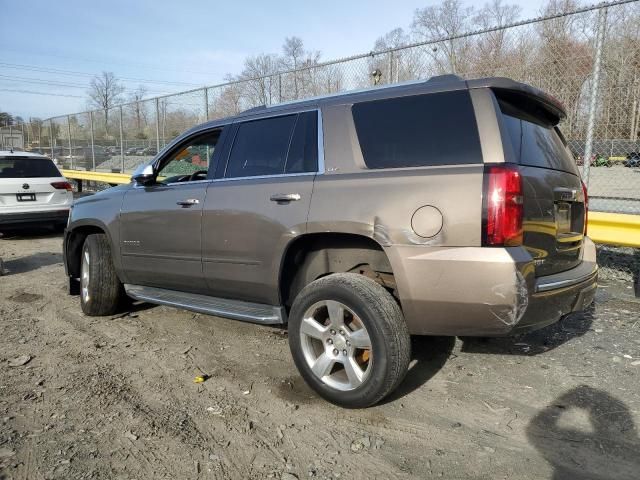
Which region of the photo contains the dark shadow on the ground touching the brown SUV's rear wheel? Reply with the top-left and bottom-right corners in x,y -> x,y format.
381,336 -> 456,404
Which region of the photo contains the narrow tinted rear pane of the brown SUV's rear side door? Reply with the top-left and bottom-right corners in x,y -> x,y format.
285,112 -> 318,173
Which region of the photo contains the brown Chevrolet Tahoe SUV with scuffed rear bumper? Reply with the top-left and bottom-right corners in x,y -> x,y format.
64,76 -> 597,407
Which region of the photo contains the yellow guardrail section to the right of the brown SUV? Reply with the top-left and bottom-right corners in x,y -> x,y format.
587,211 -> 640,247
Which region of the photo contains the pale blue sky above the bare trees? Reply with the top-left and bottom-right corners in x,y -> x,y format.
0,0 -> 543,118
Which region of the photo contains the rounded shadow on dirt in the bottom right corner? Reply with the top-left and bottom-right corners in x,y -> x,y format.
527,385 -> 640,480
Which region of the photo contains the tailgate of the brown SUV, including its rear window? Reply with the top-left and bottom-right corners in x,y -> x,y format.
498,91 -> 585,276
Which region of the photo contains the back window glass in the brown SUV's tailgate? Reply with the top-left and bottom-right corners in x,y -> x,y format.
503,115 -> 576,173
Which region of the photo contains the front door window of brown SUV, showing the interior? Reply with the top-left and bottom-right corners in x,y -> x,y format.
157,130 -> 222,184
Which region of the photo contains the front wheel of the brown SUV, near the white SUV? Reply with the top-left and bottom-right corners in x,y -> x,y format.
80,233 -> 124,317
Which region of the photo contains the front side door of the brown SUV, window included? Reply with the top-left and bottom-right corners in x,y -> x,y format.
120,129 -> 221,293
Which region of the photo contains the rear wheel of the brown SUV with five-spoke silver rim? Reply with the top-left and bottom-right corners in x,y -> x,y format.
289,273 -> 411,408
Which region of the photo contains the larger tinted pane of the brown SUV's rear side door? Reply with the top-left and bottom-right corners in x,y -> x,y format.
225,115 -> 297,178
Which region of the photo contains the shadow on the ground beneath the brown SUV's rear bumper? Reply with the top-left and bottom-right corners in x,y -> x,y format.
460,305 -> 598,356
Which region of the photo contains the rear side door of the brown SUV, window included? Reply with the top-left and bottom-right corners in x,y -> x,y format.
202,111 -> 318,305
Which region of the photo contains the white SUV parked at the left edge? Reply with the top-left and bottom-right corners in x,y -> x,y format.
0,150 -> 73,231
